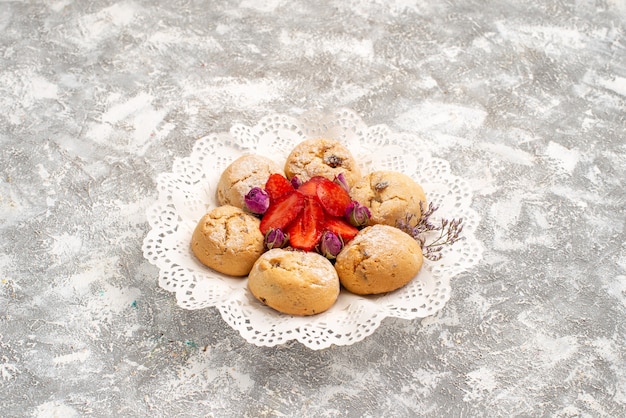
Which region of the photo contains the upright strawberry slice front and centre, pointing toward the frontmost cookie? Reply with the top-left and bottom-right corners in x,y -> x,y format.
287,197 -> 324,251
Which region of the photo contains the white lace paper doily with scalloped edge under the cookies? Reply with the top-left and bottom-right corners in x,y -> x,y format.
143,110 -> 482,349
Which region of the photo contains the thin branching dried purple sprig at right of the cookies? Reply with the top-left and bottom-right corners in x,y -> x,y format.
396,202 -> 463,261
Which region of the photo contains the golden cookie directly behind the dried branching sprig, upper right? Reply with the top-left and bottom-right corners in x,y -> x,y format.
350,171 -> 426,226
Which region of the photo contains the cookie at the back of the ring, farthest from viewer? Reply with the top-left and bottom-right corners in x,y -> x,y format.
285,139 -> 361,186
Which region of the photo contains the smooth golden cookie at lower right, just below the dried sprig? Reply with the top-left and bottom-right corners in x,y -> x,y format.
335,225 -> 424,295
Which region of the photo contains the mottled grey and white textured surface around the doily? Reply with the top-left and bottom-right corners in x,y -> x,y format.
0,0 -> 626,417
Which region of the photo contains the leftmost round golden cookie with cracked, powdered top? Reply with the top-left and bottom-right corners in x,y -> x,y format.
191,206 -> 264,276
